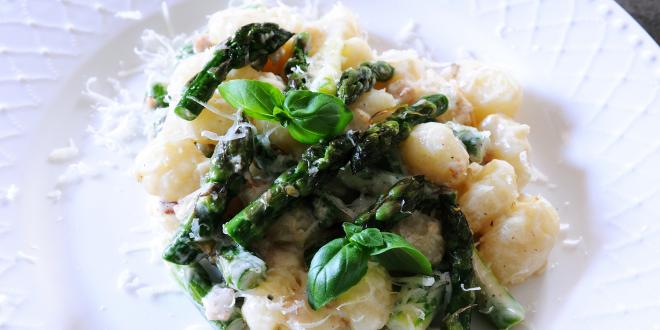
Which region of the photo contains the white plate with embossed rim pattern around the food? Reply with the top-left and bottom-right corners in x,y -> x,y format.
0,0 -> 660,329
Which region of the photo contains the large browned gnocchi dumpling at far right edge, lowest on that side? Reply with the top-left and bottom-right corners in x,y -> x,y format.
479,195 -> 559,284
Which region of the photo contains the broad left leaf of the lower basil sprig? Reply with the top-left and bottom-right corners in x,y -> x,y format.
307,238 -> 369,310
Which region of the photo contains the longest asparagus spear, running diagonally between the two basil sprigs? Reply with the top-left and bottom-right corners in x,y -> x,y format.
223,94 -> 447,246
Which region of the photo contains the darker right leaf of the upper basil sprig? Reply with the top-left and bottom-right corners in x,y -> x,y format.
283,90 -> 353,143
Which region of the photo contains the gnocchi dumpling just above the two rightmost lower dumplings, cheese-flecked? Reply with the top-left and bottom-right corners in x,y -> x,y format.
479,114 -> 532,189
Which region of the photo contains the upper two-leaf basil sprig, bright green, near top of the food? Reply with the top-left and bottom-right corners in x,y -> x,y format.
218,79 -> 353,144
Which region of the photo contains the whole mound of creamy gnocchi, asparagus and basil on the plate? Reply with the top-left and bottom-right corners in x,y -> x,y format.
136,5 -> 559,329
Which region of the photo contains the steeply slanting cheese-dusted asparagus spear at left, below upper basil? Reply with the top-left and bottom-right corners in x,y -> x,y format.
163,119 -> 254,265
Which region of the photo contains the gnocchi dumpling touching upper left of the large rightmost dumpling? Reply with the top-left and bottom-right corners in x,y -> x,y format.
458,159 -> 518,235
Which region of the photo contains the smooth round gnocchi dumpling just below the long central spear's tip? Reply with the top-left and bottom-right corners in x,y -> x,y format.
399,123 -> 470,187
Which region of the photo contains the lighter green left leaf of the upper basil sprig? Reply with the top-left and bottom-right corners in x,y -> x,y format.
218,79 -> 284,120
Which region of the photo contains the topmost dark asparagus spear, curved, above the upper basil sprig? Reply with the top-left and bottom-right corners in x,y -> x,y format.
174,23 -> 293,120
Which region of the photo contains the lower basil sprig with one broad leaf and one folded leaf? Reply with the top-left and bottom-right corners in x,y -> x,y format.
307,223 -> 431,310
